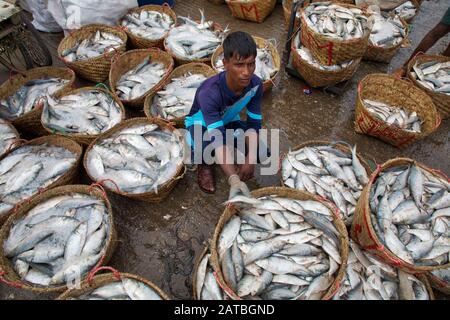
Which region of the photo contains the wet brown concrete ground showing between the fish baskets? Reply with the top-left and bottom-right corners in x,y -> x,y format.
0,0 -> 450,299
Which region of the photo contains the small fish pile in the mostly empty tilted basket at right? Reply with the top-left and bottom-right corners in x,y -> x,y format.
363,99 -> 423,133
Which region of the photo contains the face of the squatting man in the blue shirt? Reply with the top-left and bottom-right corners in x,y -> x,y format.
223,54 -> 256,89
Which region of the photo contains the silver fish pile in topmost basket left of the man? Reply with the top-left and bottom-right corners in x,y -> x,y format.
122,10 -> 175,40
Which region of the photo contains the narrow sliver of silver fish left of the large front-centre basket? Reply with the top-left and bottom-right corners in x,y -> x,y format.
194,252 -> 229,300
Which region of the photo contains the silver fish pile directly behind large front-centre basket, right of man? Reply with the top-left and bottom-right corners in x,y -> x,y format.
281,144 -> 369,225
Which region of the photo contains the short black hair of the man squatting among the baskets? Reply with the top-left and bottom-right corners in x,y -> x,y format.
223,31 -> 257,59
